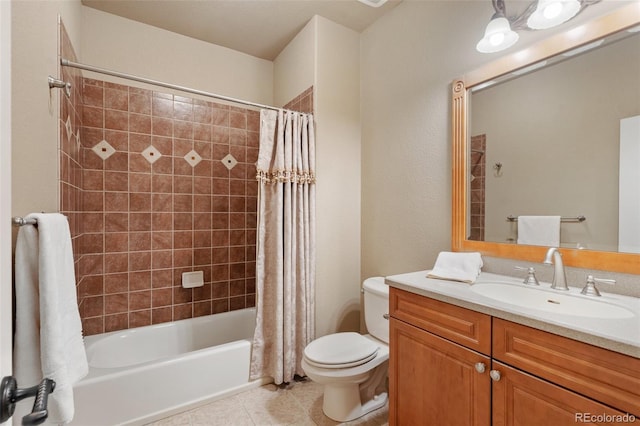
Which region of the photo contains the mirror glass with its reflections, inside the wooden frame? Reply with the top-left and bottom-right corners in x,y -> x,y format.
468,30 -> 640,253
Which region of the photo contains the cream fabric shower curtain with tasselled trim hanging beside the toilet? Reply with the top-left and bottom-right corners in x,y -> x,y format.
251,110 -> 315,384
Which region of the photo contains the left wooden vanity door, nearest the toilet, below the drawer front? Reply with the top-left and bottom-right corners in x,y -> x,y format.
389,317 -> 491,426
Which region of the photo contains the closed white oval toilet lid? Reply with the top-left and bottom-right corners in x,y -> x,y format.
304,332 -> 378,368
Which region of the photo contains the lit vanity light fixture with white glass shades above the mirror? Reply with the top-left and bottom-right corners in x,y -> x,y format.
476,0 -> 600,53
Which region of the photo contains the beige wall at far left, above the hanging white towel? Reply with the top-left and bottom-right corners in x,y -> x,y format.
11,0 -> 81,216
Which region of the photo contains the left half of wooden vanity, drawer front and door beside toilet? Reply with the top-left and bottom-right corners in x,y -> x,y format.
389,288 -> 491,426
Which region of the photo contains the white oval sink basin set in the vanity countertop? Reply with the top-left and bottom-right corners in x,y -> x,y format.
471,283 -> 635,319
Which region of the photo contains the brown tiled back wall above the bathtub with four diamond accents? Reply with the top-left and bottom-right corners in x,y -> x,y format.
78,78 -> 259,335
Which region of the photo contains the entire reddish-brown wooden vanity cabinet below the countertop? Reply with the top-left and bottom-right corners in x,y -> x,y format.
389,287 -> 640,426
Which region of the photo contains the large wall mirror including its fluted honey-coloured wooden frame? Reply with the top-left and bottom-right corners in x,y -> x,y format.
452,4 -> 640,274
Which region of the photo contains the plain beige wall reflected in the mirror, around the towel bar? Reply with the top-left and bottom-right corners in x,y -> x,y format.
470,36 -> 640,251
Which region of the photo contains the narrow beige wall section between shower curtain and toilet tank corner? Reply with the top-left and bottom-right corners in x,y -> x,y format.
315,17 -> 361,335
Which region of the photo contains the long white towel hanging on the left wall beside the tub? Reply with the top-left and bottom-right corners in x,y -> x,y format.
13,213 -> 89,423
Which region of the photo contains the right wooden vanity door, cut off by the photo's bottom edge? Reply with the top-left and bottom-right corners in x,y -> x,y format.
492,361 -> 638,426
